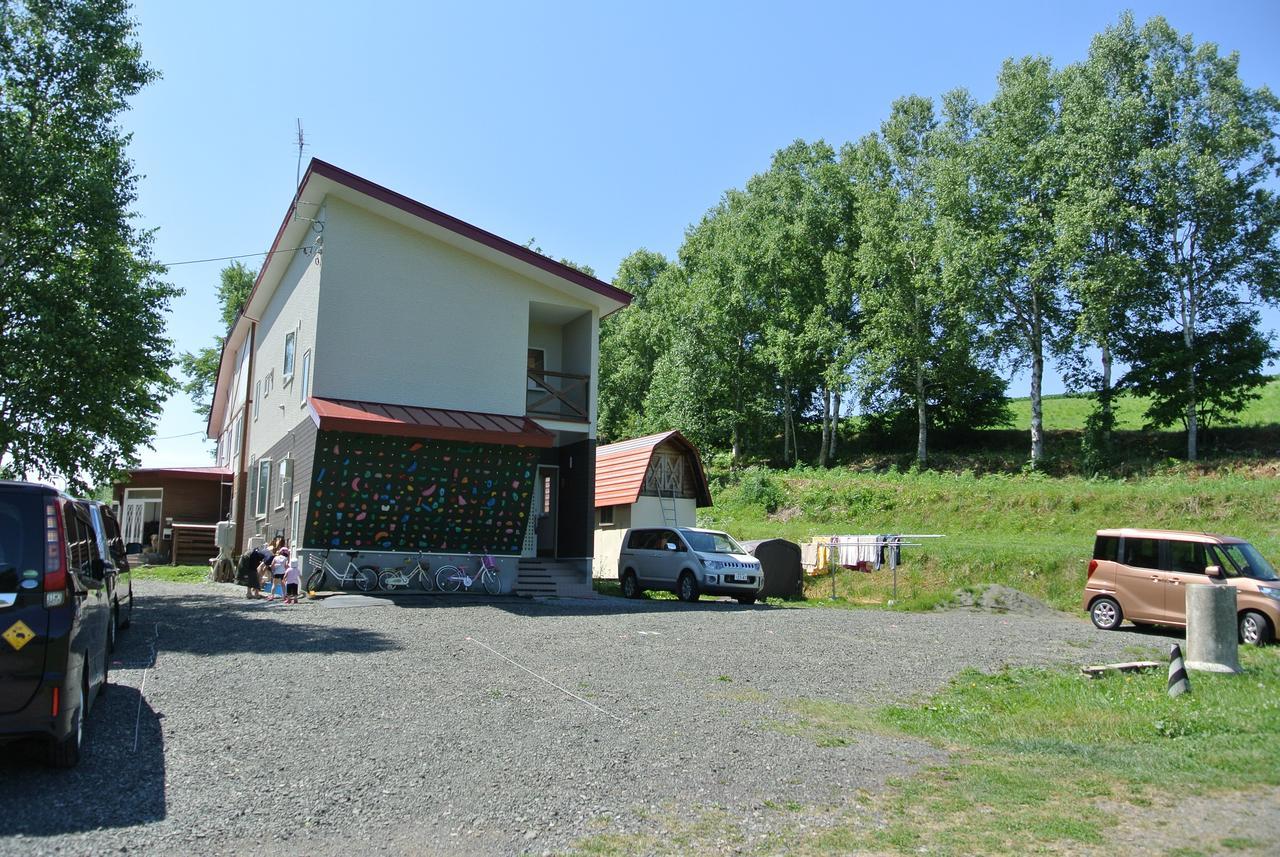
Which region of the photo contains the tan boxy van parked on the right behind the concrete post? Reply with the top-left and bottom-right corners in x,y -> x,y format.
1084,530 -> 1280,646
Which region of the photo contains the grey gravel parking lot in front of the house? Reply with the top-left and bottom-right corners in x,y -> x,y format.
0,582 -> 1165,854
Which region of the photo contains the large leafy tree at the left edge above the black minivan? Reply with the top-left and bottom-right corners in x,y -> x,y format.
0,0 -> 178,490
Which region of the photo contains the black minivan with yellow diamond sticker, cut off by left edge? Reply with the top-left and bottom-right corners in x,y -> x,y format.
0,481 -> 111,767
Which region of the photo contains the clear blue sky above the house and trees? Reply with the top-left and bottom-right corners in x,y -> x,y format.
123,0 -> 1280,467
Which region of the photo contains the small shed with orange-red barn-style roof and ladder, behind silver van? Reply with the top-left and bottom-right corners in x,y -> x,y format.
591,431 -> 712,578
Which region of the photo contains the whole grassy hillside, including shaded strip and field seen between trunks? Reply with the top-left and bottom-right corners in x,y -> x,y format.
699,380 -> 1280,610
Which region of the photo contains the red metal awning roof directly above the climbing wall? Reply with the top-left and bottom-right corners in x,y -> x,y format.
310,395 -> 556,446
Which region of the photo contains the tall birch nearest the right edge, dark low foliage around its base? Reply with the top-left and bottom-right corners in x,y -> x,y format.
1121,18 -> 1280,460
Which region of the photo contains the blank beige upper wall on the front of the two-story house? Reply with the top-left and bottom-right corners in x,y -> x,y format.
320,197 -> 598,414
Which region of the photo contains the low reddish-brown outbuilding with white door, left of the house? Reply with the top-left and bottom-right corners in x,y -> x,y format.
113,467 -> 232,565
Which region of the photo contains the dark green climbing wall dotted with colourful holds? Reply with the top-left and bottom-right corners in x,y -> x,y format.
303,431 -> 538,555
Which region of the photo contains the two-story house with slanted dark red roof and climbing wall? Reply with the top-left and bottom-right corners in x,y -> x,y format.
209,160 -> 631,592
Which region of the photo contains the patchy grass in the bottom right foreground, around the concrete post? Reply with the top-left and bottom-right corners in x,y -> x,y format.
577,647 -> 1280,857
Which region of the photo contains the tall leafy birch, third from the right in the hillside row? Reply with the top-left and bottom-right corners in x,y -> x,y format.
947,58 -> 1070,467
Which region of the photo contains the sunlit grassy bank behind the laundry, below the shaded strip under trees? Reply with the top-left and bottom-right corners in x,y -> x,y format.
699,462 -> 1280,610
